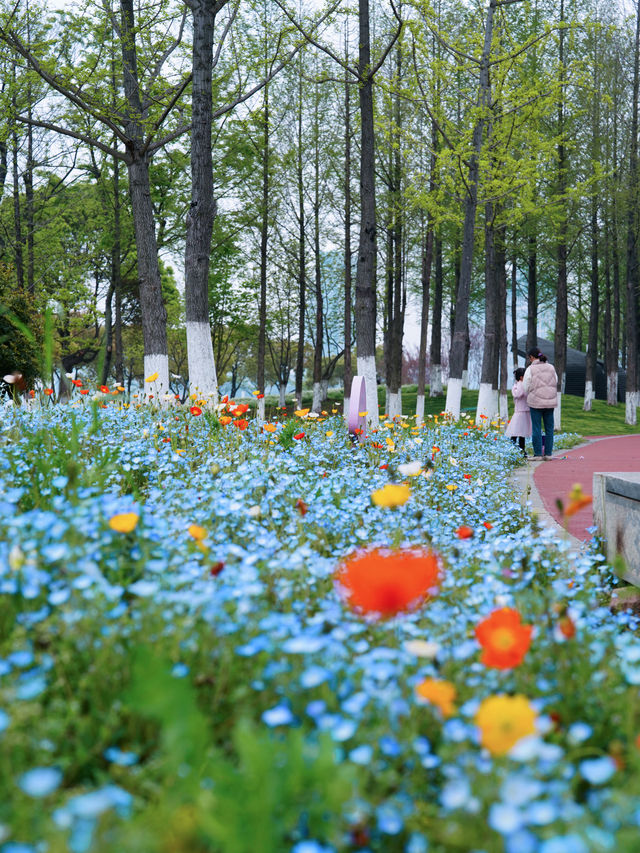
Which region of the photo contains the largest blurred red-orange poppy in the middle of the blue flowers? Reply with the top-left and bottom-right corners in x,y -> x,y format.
335,548 -> 441,618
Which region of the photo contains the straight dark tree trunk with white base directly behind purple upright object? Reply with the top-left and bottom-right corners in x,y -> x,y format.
355,0 -> 378,426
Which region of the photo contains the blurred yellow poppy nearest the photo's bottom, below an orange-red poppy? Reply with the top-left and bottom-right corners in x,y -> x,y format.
475,696 -> 536,755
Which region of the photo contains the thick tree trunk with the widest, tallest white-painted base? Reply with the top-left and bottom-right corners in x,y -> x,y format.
184,0 -> 219,403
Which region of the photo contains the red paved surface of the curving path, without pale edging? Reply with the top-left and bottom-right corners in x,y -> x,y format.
533,435 -> 640,541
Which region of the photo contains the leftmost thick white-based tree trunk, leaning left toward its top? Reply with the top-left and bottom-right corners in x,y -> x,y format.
120,0 -> 169,396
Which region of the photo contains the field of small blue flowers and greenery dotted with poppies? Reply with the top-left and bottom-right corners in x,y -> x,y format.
0,396 -> 640,853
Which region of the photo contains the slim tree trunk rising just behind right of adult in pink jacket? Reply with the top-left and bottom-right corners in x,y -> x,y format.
554,0 -> 568,429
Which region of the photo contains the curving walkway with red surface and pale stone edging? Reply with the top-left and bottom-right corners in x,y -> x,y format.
515,434 -> 640,547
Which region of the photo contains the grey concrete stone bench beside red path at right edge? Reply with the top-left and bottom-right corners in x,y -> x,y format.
593,472 -> 640,586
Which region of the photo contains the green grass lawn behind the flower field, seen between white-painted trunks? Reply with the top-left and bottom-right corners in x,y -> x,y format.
252,385 -> 639,435
